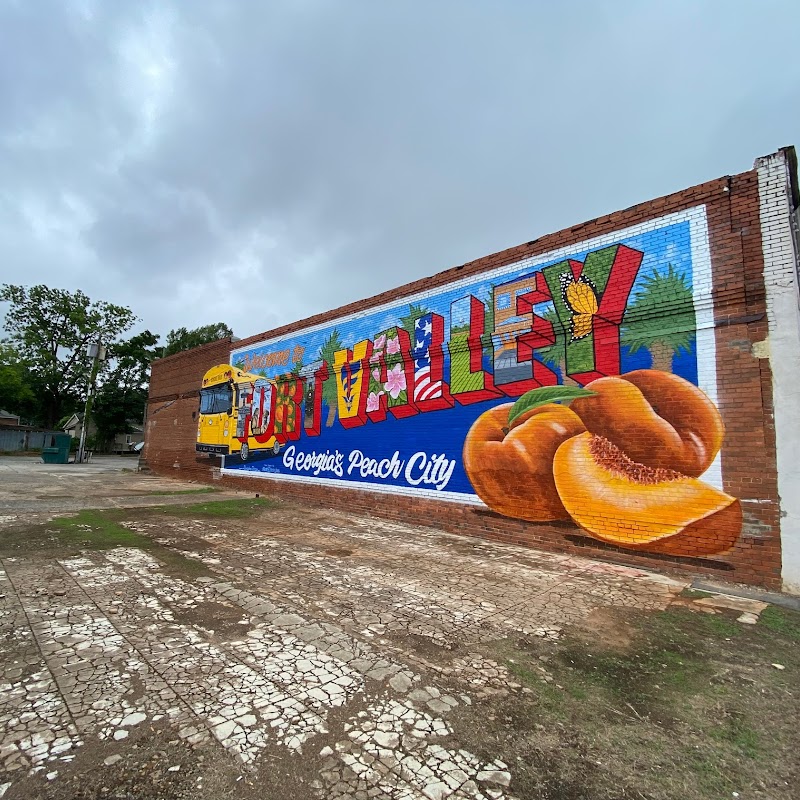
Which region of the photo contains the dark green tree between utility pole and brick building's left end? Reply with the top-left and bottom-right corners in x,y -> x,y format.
92,331 -> 159,447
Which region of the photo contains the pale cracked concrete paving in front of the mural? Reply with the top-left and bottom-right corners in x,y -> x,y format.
0,460 -> 700,800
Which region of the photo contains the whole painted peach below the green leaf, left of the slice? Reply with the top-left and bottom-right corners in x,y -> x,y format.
464,403 -> 586,522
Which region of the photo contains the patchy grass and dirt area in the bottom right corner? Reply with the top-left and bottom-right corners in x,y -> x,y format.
454,606 -> 800,800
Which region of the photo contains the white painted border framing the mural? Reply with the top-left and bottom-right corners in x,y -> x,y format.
221,206 -> 722,507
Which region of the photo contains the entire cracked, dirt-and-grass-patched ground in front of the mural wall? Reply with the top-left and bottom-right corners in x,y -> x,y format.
0,458 -> 800,800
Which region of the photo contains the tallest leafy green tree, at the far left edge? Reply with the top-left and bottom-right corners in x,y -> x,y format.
0,284 -> 136,427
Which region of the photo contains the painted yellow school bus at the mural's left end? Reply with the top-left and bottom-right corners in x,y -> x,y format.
195,364 -> 281,461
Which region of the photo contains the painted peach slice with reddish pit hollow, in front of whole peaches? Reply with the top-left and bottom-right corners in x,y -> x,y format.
553,433 -> 742,555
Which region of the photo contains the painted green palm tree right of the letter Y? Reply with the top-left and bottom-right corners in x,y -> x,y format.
621,264 -> 697,372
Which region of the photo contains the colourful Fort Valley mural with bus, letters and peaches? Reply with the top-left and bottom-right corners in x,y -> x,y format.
197,208 -> 742,556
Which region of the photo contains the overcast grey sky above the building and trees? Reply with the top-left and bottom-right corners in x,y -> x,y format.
0,0 -> 800,336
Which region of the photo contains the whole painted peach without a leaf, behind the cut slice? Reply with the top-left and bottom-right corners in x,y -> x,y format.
571,369 -> 725,478
